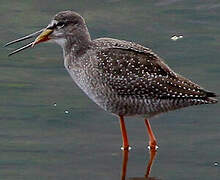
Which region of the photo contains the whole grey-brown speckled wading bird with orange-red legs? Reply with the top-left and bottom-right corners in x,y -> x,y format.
6,11 -> 217,149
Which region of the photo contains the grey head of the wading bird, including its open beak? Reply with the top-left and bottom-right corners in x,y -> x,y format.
5,11 -> 90,55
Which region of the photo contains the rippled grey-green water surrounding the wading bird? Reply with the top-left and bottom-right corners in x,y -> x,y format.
0,0 -> 220,180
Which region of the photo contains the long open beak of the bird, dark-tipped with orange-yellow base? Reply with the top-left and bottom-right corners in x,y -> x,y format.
5,28 -> 53,56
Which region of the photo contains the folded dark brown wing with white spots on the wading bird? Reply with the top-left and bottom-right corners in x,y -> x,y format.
94,38 -> 215,98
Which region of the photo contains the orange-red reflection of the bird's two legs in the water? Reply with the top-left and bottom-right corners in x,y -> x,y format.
121,149 -> 159,180
